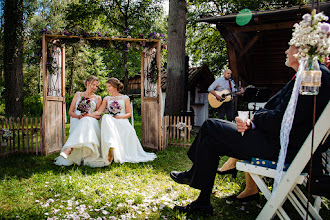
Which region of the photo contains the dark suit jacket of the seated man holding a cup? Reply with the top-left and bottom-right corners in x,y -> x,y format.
253,65 -> 330,161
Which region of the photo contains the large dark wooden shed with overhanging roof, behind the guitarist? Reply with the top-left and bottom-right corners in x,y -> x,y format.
198,2 -> 330,93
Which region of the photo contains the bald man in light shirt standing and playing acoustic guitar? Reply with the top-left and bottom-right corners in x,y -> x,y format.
208,69 -> 244,121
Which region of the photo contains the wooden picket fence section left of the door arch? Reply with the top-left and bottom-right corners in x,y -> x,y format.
0,118 -> 43,157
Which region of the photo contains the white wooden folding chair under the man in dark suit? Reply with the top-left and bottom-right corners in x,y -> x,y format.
236,102 -> 330,220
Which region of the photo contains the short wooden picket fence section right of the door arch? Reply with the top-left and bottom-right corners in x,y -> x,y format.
162,116 -> 192,149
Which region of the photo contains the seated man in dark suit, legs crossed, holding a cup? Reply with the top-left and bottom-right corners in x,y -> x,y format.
170,46 -> 330,214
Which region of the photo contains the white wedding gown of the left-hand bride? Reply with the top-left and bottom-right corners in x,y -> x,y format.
54,92 -> 101,167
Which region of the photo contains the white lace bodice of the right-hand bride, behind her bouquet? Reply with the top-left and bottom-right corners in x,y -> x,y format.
104,95 -> 129,115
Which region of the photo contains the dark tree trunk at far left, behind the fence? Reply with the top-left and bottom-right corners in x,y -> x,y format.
3,0 -> 24,116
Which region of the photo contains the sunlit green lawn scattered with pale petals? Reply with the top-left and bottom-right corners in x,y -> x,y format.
0,121 -> 330,220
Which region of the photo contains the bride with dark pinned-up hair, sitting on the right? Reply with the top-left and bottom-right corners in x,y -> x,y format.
89,78 -> 156,166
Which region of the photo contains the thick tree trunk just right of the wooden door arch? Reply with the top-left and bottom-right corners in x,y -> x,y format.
165,0 -> 187,115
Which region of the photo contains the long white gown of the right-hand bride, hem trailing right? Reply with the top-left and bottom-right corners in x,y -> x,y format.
101,95 -> 157,166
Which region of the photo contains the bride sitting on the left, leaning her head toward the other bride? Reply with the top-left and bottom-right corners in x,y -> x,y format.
54,76 -> 102,167
